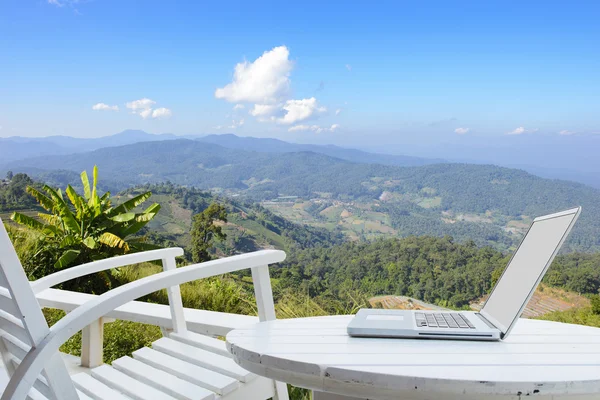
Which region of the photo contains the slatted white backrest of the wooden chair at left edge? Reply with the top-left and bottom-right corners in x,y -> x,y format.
0,219 -> 77,400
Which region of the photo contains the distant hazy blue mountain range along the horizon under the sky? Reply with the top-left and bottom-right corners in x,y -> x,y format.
0,130 -> 600,188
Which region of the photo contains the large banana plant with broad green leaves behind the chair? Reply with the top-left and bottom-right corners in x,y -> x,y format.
11,167 -> 160,293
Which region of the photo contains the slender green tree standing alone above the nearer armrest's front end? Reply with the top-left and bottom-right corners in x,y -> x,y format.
190,203 -> 227,263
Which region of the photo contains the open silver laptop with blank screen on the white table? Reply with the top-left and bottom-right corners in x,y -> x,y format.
347,207 -> 581,340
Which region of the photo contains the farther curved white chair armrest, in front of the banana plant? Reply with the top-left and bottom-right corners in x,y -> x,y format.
31,247 -> 183,294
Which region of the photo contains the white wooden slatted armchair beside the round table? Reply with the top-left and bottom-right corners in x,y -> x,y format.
0,220 -> 288,400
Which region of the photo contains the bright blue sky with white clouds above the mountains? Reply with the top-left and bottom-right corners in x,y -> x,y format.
0,0 -> 600,147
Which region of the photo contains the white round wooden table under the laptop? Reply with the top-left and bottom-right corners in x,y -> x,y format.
227,316 -> 600,400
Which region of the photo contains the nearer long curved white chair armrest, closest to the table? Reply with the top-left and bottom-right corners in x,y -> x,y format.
2,250 -> 286,400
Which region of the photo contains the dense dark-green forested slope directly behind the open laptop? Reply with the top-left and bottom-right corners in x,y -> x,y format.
272,236 -> 600,308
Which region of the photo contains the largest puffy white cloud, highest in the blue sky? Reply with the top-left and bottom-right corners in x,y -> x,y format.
215,46 -> 293,104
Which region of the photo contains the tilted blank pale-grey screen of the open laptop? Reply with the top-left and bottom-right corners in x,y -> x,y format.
482,208 -> 580,333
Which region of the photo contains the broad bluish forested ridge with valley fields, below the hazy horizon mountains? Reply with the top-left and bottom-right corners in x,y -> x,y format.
10,140 -> 600,251
